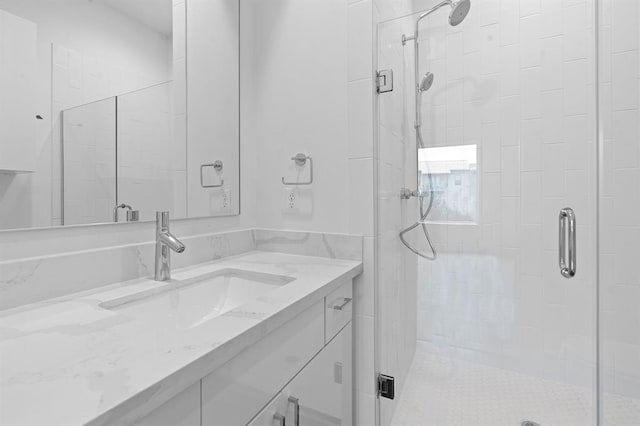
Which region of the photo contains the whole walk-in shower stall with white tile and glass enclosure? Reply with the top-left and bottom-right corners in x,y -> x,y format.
374,0 -> 640,426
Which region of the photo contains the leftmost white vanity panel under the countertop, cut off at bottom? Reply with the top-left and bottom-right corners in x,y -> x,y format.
135,382 -> 200,426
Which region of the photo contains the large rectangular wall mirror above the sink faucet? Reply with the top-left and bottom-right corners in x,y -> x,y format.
0,0 -> 240,229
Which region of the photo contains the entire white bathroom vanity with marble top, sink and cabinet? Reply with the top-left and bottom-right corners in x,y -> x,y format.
0,251 -> 362,425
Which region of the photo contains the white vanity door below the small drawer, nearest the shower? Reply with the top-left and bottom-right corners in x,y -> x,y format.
286,323 -> 353,426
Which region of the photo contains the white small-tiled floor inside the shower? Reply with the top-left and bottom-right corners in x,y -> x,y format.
392,343 -> 640,426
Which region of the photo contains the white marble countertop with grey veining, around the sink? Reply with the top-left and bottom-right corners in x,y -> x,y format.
0,251 -> 362,425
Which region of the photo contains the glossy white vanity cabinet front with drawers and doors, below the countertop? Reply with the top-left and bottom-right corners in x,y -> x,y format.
129,281 -> 353,426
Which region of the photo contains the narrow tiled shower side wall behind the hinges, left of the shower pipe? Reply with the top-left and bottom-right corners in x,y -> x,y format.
375,13 -> 418,425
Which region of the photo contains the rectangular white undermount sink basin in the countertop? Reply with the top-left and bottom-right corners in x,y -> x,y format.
100,269 -> 294,329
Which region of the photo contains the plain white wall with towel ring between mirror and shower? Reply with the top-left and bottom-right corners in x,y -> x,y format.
241,0 -> 350,232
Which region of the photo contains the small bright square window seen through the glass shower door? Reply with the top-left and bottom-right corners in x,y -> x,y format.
418,145 -> 478,224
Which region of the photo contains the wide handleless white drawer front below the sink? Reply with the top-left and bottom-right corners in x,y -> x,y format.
202,300 -> 324,426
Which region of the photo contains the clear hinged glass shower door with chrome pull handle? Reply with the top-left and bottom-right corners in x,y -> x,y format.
376,0 -> 597,426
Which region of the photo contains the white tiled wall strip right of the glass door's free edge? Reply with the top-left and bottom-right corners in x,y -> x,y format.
599,0 -> 640,402
